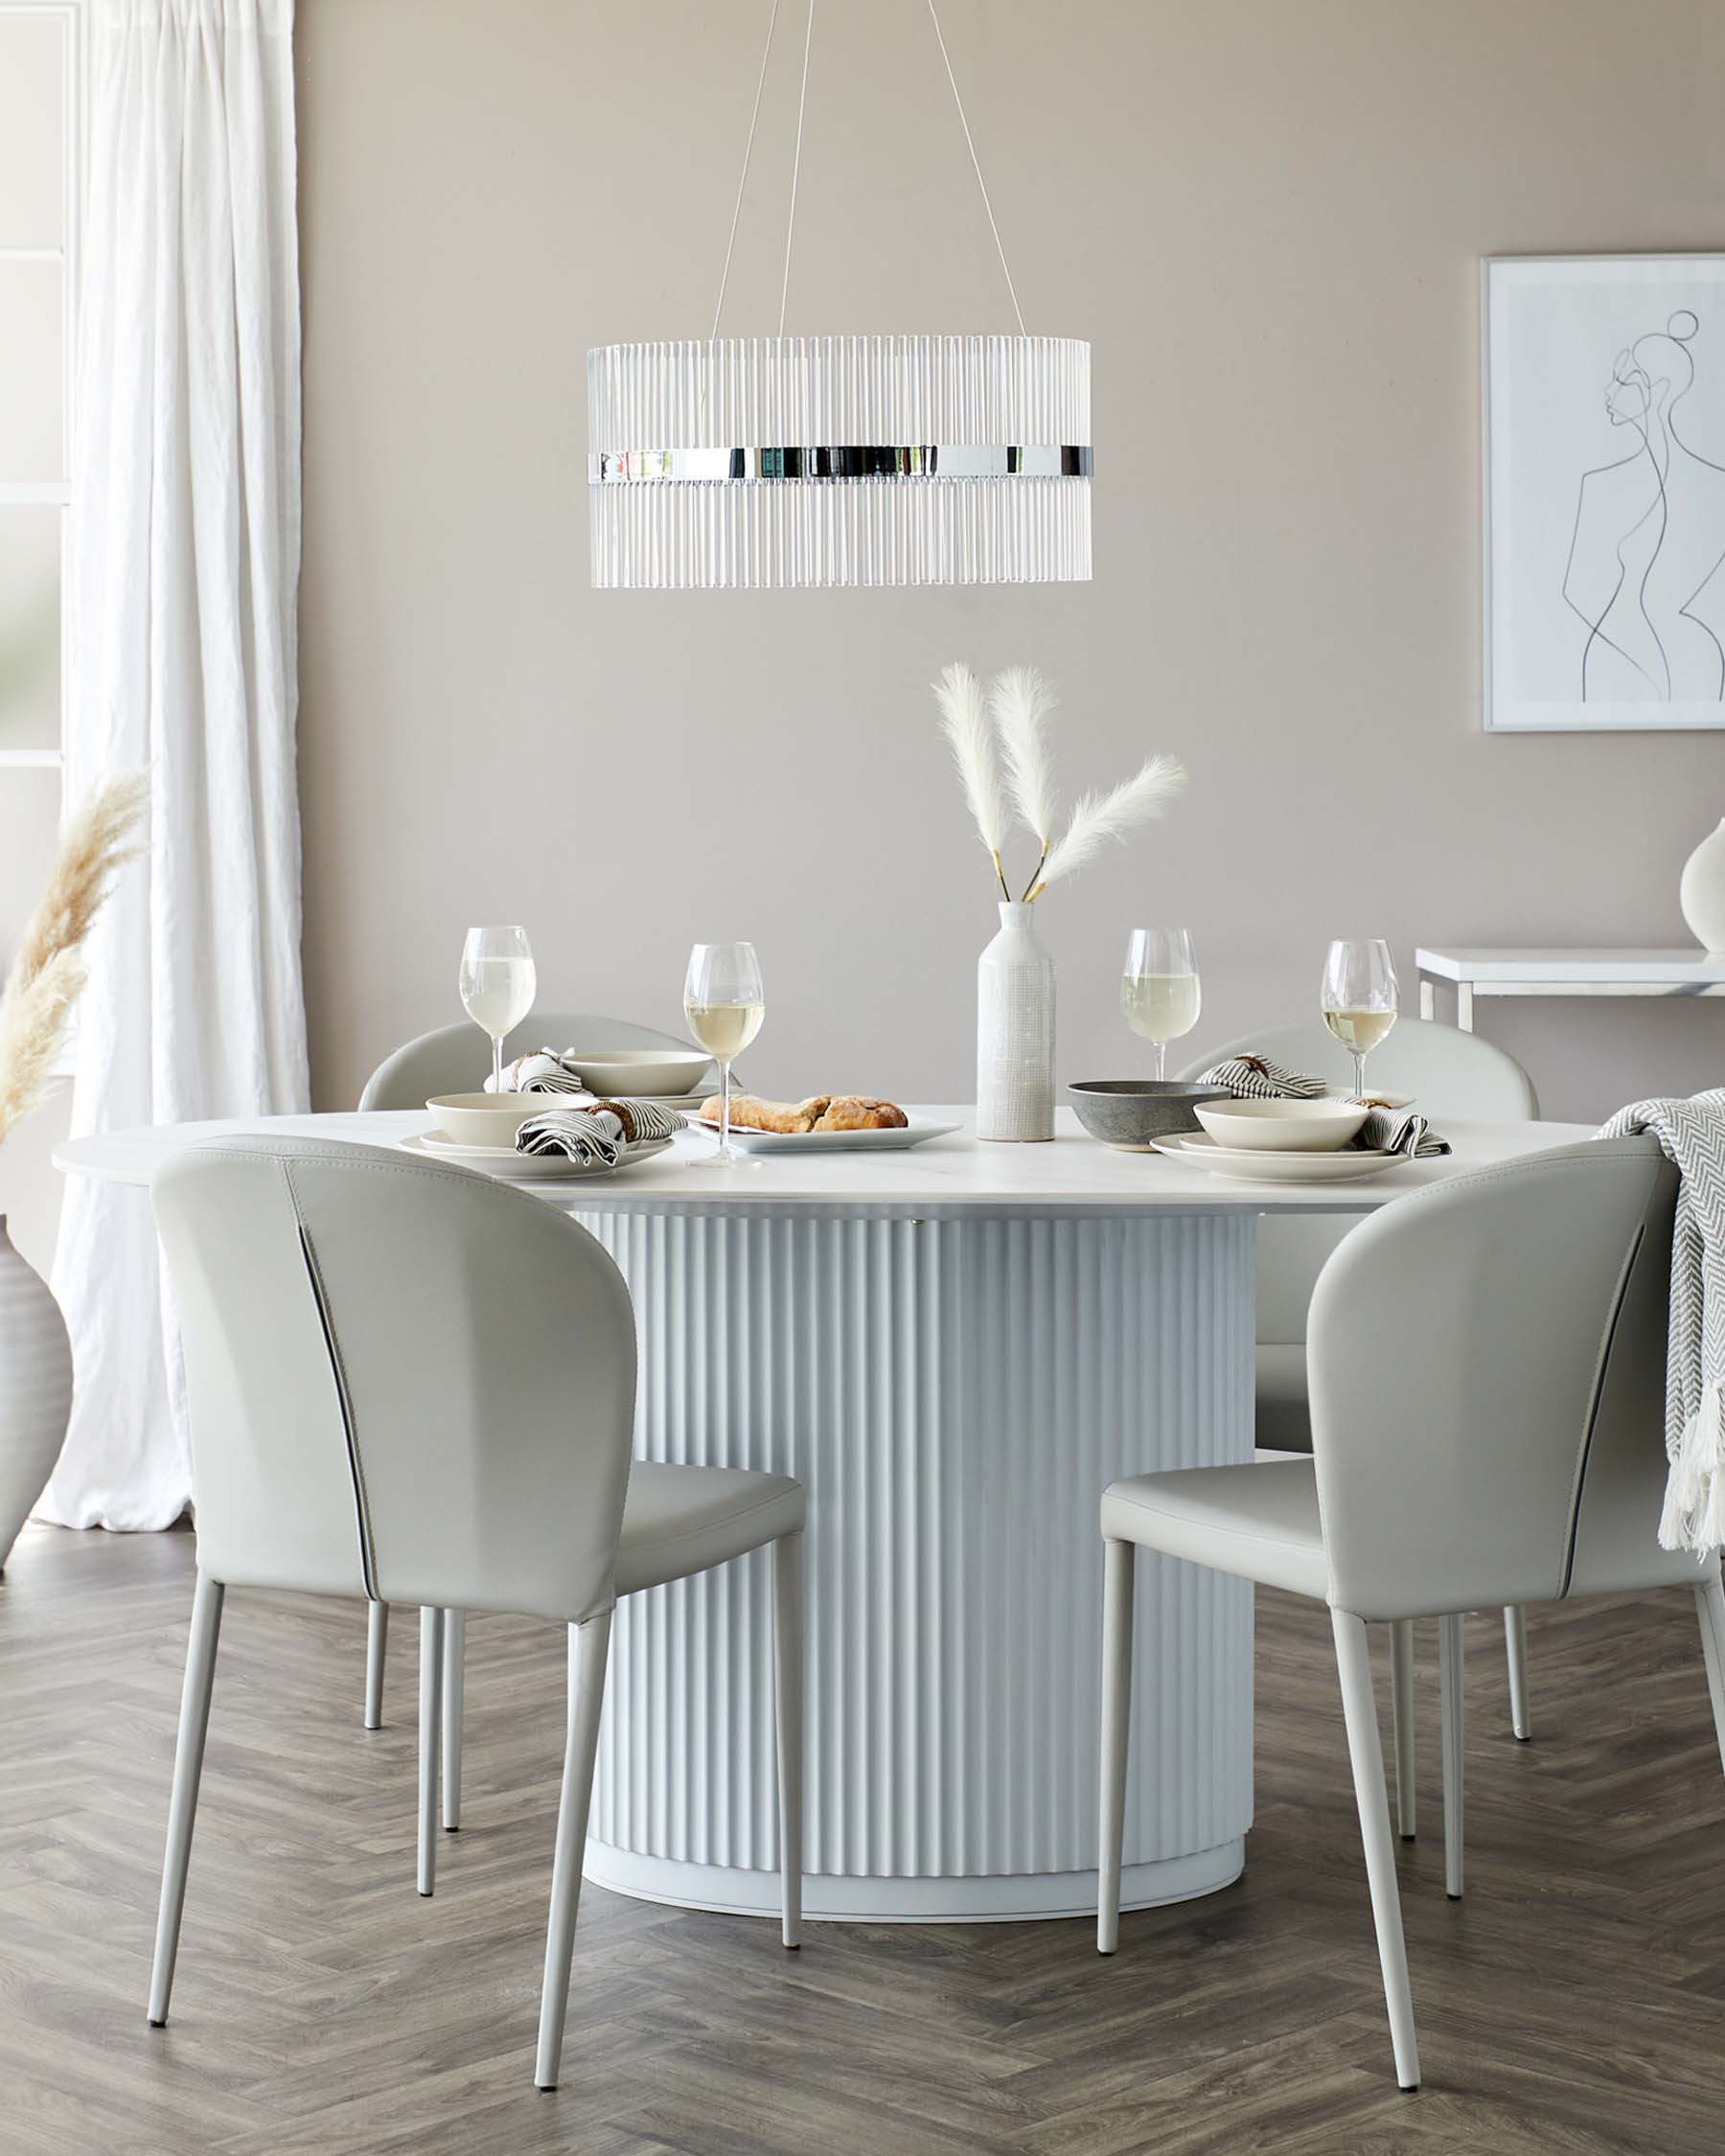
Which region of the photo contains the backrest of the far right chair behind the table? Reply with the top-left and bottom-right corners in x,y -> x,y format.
1175,1018 -> 1540,1342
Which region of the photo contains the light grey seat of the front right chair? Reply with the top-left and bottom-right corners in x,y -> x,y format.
1102,1459 -> 1330,1602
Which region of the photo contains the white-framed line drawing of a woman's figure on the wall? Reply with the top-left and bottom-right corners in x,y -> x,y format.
1482,255 -> 1725,733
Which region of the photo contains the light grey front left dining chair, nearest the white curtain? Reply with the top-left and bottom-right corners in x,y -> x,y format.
149,1138 -> 804,2087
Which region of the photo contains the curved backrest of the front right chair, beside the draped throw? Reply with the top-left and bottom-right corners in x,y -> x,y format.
1307,1138 -> 1704,1617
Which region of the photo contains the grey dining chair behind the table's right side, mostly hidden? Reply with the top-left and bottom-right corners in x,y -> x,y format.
1180,1018 -> 1540,1794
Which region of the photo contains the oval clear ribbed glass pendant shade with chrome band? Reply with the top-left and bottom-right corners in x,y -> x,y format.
586,336 -> 1092,588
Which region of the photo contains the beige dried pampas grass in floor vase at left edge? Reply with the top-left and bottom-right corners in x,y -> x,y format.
0,772 -> 149,1138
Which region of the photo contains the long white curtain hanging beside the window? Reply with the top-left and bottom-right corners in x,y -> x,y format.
39,0 -> 307,1528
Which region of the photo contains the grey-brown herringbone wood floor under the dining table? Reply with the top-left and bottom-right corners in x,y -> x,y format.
0,1528 -> 1725,2156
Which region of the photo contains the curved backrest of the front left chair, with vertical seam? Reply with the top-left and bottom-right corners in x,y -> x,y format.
153,1138 -> 636,1621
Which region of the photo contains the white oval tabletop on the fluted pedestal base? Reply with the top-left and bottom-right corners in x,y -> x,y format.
54,1109 -> 1594,1214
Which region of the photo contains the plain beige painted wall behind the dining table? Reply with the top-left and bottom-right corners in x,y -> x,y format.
298,0 -> 1725,1114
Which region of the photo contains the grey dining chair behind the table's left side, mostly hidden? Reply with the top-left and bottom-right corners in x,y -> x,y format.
360,1011 -> 707,1742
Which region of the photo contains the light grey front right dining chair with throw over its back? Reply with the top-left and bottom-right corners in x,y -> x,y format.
1095,1138 -> 1725,2089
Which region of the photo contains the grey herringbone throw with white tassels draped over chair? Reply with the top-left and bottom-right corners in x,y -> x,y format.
1600,1087 -> 1725,1552
